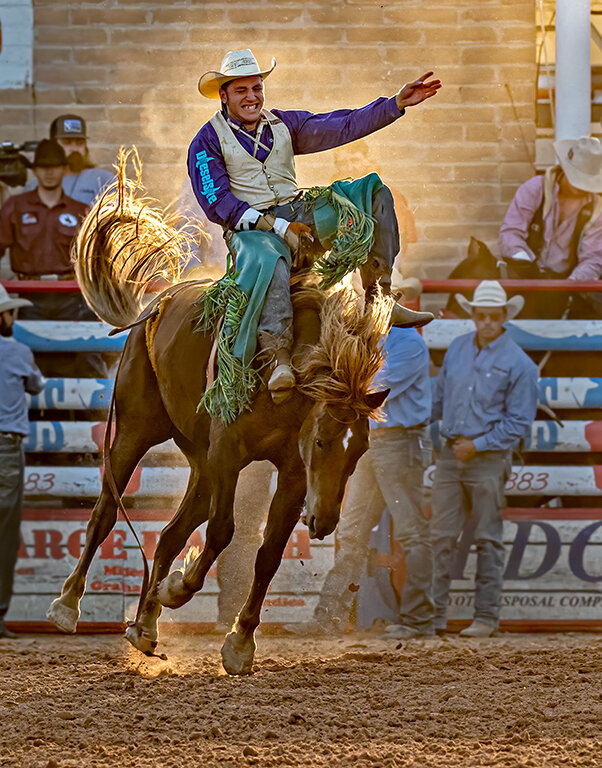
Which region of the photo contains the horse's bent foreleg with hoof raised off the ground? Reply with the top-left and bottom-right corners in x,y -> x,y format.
157,471 -> 238,608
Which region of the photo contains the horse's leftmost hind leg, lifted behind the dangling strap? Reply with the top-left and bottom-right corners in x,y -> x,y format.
46,430 -> 157,632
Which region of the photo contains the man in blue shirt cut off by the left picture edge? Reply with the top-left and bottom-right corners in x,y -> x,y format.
0,285 -> 44,638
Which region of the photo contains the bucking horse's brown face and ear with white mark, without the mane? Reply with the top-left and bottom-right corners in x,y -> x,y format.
299,390 -> 389,540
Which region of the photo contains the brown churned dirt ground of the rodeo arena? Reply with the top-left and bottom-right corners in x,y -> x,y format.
0,634 -> 602,768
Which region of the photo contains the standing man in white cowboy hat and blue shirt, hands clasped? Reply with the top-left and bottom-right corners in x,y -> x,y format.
431,280 -> 537,637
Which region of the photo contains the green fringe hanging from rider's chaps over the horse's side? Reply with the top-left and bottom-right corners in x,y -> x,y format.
195,272 -> 261,424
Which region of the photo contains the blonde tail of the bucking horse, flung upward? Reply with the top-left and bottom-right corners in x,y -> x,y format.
72,147 -> 201,328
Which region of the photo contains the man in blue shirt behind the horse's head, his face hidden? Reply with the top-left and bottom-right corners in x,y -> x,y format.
285,328 -> 434,639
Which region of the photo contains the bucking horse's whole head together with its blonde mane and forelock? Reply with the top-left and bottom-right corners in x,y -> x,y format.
296,289 -> 392,539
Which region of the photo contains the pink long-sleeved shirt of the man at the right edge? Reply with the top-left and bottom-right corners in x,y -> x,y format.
499,176 -> 602,280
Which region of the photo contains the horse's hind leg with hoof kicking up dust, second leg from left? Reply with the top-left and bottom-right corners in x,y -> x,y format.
125,469 -> 210,653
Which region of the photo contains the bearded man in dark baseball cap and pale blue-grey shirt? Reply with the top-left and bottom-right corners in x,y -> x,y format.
44,114 -> 115,206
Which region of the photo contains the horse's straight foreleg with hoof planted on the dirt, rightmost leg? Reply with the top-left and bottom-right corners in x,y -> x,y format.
222,464 -> 306,675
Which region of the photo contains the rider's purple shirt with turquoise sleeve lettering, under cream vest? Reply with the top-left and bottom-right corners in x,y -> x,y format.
188,96 -> 404,229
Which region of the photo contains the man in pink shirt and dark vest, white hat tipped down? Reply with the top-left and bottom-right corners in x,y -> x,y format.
499,136 -> 602,280
